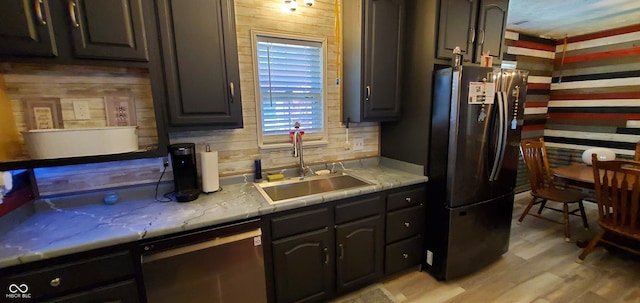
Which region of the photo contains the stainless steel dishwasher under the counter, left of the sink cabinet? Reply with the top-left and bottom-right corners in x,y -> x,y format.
140,220 -> 267,303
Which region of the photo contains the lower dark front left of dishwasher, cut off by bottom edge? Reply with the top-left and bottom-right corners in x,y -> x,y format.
46,280 -> 140,303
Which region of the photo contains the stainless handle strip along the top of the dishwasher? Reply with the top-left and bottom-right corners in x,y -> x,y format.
141,228 -> 262,264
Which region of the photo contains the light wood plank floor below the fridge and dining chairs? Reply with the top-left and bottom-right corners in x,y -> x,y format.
382,193 -> 640,303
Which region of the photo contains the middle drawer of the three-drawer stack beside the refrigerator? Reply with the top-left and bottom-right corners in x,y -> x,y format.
387,205 -> 425,243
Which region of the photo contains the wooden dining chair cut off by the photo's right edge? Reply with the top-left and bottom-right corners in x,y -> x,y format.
576,155 -> 640,263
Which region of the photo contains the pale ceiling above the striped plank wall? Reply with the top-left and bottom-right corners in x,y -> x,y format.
507,0 -> 640,39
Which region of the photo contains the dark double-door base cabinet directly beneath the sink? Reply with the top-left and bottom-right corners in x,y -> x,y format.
267,193 -> 385,302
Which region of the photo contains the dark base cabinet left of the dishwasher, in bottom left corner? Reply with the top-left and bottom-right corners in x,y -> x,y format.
0,247 -> 140,303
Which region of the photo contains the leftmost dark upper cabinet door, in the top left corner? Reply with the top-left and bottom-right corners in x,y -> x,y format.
0,0 -> 58,56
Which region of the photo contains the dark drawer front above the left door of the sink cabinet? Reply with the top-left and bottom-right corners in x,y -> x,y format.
271,207 -> 331,240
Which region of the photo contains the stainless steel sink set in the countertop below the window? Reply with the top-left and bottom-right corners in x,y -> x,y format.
256,174 -> 371,204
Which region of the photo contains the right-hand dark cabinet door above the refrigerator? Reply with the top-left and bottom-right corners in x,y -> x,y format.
475,0 -> 509,64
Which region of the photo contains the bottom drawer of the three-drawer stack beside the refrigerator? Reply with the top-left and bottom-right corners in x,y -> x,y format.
384,235 -> 422,275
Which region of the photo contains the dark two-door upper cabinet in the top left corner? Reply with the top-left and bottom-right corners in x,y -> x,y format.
0,0 -> 148,63
